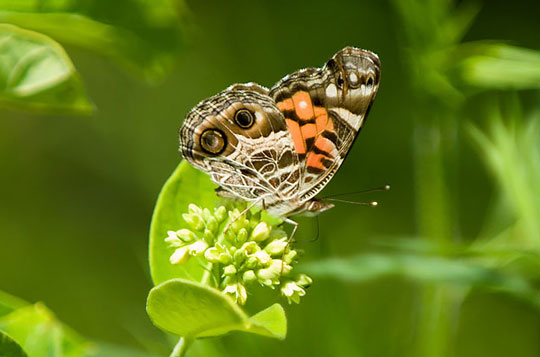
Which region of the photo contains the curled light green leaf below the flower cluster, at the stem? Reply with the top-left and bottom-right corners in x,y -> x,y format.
146,279 -> 287,339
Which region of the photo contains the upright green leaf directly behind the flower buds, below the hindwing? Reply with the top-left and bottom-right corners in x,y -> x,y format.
150,161 -> 219,285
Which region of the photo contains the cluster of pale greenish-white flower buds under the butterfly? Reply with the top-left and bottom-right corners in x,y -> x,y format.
165,204 -> 311,305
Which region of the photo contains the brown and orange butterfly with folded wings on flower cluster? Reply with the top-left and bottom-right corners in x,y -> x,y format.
180,47 -> 381,223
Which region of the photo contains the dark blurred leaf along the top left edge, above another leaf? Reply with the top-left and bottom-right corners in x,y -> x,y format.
0,0 -> 185,82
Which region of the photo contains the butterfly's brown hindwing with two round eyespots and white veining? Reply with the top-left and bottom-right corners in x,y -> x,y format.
180,83 -> 300,205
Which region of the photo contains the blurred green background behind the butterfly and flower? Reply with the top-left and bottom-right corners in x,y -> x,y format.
0,0 -> 540,356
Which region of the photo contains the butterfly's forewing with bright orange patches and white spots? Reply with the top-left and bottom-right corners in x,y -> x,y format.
269,47 -> 381,202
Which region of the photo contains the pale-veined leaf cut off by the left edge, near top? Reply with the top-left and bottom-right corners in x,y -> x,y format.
0,24 -> 93,114
